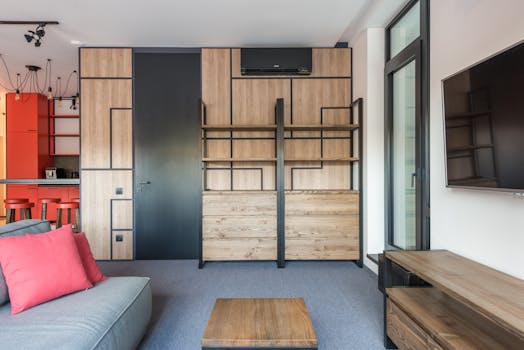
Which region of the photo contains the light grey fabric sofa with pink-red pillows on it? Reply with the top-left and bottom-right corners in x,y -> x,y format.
0,220 -> 151,350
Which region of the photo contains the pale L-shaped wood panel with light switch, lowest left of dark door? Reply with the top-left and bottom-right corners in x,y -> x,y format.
80,170 -> 133,260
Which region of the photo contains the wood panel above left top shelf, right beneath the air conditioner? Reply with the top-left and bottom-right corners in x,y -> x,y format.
233,79 -> 291,125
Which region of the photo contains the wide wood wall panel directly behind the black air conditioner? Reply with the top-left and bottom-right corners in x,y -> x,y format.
231,48 -> 351,79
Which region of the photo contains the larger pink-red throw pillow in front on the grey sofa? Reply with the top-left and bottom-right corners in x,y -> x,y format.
0,225 -> 93,315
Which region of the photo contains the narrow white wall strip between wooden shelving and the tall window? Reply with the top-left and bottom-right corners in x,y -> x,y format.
352,28 -> 384,272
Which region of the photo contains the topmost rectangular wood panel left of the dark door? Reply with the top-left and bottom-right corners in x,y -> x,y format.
80,48 -> 133,77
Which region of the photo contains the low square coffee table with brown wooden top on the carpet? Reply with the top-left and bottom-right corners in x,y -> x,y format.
202,298 -> 318,350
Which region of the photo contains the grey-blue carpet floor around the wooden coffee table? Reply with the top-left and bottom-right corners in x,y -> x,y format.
100,260 -> 384,350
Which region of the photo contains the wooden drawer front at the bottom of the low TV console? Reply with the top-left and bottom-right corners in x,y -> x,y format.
387,299 -> 442,350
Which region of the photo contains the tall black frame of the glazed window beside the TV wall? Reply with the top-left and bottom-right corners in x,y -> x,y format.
384,0 -> 430,250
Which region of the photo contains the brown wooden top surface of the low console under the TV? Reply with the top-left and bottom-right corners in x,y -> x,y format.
385,250 -> 524,345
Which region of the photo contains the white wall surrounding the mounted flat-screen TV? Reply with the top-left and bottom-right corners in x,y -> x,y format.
430,0 -> 524,279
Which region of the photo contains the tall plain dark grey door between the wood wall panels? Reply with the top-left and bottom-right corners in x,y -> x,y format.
134,51 -> 201,259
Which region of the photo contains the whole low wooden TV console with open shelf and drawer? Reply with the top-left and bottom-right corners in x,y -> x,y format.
383,250 -> 524,350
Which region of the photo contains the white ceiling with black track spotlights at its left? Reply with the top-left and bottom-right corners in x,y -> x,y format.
0,0 -> 405,96
